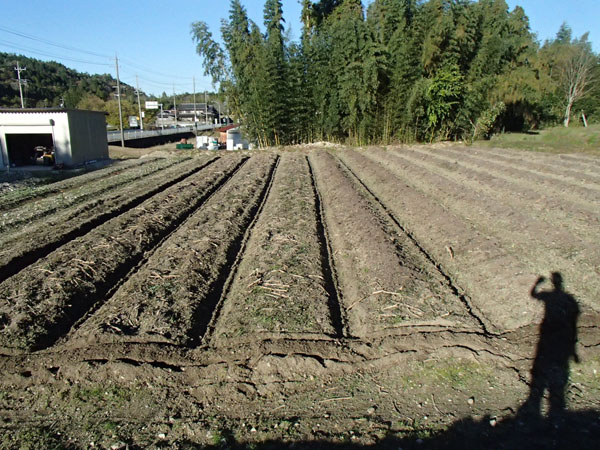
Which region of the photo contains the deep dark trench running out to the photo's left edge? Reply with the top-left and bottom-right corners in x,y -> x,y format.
0,157 -> 219,283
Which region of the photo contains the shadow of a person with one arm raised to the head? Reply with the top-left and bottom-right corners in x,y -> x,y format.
520,272 -> 579,417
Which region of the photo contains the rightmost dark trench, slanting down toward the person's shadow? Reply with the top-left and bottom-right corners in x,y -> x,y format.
334,155 -> 496,336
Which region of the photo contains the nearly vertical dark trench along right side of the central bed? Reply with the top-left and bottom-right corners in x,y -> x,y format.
305,156 -> 349,337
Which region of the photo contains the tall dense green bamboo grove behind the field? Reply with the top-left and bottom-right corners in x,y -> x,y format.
192,0 -> 600,146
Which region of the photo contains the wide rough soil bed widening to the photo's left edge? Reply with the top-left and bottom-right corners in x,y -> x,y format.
0,158 -> 242,351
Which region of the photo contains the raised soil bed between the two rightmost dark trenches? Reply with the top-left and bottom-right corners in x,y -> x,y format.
310,152 -> 474,337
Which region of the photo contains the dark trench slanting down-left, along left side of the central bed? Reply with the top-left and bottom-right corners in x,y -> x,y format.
202,155 -> 281,345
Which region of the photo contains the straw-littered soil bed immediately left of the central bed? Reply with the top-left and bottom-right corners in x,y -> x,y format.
65,156 -> 275,346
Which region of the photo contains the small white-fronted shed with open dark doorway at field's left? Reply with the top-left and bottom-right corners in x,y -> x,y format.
0,108 -> 108,167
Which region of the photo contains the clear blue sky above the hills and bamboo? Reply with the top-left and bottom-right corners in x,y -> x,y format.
0,0 -> 600,95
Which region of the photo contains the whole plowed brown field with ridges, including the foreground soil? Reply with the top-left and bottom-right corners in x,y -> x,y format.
0,146 -> 600,449
